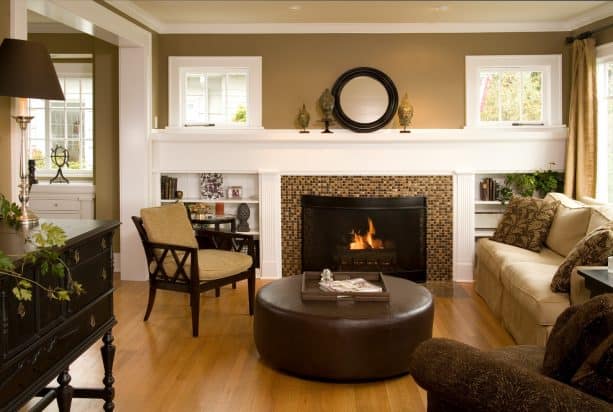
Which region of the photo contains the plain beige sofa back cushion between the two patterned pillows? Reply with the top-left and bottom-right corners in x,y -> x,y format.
545,204 -> 592,256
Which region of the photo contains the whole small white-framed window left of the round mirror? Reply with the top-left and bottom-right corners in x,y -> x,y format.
169,56 -> 262,128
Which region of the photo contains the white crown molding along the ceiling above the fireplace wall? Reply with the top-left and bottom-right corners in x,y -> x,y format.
105,0 -> 613,34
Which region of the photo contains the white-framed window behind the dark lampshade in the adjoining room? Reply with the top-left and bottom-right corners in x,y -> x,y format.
29,63 -> 94,177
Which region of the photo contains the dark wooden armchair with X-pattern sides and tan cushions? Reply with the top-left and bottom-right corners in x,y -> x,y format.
132,203 -> 255,337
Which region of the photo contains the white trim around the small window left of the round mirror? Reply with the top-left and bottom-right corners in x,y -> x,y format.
168,56 -> 262,131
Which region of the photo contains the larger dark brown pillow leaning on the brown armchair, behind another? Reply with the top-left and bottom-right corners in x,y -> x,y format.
543,293 -> 613,383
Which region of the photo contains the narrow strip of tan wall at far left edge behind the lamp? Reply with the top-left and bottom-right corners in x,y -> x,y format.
0,1 -> 11,198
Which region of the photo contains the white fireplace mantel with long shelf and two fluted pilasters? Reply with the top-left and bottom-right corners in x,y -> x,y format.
130,126 -> 568,280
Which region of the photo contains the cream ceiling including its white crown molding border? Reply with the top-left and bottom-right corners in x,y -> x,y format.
106,0 -> 613,33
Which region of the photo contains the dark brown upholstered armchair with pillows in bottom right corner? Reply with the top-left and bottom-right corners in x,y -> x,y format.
411,295 -> 613,412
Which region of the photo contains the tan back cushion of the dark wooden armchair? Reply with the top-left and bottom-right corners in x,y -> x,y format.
140,203 -> 198,248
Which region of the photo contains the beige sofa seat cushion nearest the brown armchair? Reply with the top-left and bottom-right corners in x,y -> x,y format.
500,262 -> 570,326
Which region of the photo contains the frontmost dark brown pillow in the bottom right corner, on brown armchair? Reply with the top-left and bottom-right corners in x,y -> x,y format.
570,333 -> 613,402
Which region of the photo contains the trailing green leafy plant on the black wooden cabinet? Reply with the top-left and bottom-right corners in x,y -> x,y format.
0,195 -> 83,308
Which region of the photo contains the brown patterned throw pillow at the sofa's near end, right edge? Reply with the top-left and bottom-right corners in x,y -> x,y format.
551,224 -> 613,292
